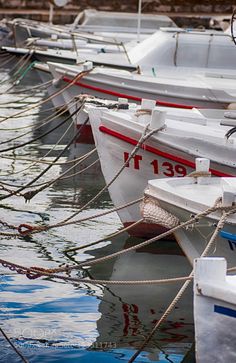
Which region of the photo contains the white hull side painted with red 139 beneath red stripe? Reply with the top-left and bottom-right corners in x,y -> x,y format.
90,111 -> 234,237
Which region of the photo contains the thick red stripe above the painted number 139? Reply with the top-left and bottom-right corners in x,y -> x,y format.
99,125 -> 235,177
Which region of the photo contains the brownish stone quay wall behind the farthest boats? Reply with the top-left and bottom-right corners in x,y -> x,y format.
0,0 -> 233,23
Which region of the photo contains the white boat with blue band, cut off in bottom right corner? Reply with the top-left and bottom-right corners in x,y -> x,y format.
194,258 -> 236,363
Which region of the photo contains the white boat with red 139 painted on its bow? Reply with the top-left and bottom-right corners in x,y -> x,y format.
88,101 -> 236,237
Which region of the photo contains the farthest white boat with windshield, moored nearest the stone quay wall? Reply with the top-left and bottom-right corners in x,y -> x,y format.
6,10 -> 175,46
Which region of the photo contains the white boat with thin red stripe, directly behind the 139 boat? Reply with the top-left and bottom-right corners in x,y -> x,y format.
44,57 -> 236,121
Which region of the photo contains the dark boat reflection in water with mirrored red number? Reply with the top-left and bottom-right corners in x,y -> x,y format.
84,237 -> 194,361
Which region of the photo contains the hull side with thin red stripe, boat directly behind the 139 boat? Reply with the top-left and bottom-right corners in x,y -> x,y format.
57,73 -> 231,109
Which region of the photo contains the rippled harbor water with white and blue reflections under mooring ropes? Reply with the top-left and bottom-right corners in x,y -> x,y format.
0,64 -> 194,363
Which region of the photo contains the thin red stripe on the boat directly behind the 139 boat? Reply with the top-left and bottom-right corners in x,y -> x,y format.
63,76 -> 200,109
